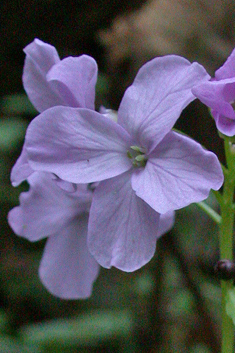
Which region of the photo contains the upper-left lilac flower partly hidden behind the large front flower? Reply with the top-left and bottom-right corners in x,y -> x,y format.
11,39 -> 97,186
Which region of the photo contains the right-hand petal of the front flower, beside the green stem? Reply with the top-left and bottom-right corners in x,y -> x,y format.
132,132 -> 223,213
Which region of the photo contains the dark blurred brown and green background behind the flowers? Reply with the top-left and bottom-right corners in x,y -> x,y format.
0,0 -> 235,353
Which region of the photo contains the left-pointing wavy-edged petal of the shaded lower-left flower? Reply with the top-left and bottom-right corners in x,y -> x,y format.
8,172 -> 91,241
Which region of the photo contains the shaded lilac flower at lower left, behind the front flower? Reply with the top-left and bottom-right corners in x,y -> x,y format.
8,172 -> 174,299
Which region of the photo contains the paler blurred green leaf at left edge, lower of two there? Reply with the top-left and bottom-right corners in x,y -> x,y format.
0,118 -> 28,151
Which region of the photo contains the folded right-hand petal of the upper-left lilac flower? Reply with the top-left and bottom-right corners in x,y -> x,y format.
47,55 -> 97,109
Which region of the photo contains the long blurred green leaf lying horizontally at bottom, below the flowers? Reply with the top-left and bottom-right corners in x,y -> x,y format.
20,311 -> 132,348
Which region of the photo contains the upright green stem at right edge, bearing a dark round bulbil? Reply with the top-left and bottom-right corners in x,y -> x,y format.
219,137 -> 235,353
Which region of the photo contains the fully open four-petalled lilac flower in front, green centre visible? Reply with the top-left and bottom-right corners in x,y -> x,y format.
25,55 -> 223,271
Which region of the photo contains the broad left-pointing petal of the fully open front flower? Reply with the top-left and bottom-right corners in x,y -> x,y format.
26,107 -> 131,183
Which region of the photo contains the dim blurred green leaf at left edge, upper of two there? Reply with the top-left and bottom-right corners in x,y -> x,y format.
1,93 -> 38,115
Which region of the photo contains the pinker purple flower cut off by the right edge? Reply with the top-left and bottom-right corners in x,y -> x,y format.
192,49 -> 235,136
